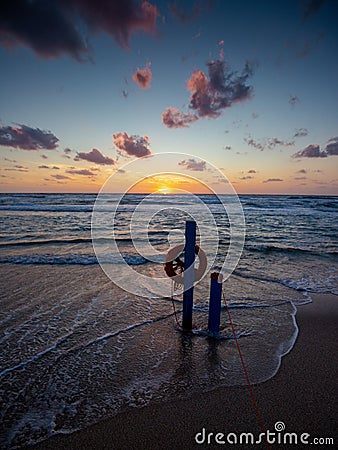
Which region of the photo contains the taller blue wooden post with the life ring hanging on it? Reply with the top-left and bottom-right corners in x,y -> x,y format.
182,220 -> 196,330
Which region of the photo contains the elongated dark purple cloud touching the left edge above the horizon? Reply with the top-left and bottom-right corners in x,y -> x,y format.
0,125 -> 59,150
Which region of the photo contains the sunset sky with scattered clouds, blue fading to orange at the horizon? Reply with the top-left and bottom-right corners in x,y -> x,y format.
0,0 -> 338,195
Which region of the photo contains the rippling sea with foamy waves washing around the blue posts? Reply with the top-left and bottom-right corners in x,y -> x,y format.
0,194 -> 338,448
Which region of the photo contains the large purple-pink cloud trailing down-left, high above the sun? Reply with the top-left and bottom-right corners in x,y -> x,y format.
162,60 -> 253,128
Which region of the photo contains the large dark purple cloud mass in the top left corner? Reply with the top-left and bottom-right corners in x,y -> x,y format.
0,0 -> 159,61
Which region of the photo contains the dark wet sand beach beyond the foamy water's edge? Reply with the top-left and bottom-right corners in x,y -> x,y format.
29,294 -> 338,450
